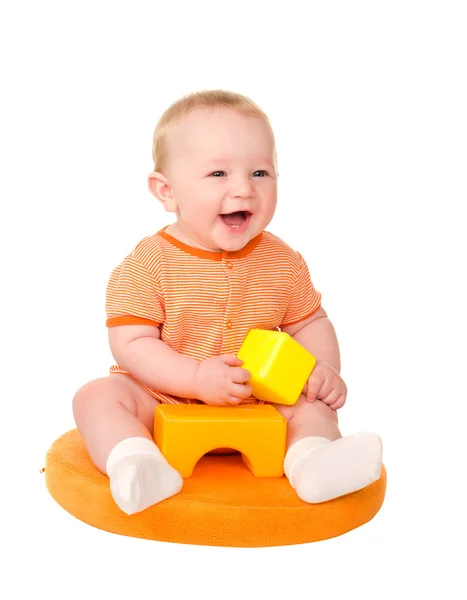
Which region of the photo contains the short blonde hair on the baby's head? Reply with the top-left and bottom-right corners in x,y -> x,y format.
152,90 -> 276,172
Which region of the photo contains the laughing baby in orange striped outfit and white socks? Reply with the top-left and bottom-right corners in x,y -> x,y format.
73,91 -> 382,514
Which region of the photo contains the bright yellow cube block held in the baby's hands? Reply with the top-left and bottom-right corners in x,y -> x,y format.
237,329 -> 316,404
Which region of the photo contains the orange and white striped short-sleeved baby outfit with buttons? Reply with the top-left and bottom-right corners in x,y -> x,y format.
106,227 -> 321,404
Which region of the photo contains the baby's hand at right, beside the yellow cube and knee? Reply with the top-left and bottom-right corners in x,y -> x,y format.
303,361 -> 347,410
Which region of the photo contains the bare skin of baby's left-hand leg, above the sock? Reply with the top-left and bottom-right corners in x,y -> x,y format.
73,374 -> 159,473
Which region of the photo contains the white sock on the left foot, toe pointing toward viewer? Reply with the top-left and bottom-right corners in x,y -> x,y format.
106,437 -> 183,515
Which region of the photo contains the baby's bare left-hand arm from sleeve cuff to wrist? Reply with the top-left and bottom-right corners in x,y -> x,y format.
109,325 -> 199,398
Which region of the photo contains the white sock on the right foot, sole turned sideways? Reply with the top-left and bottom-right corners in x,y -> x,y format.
284,433 -> 383,504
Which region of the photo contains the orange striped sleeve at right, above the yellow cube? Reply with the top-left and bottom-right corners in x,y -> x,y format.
280,252 -> 321,327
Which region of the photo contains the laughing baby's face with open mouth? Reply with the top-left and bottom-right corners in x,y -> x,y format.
166,109 -> 277,252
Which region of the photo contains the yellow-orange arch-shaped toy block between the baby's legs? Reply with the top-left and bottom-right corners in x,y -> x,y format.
154,404 -> 287,478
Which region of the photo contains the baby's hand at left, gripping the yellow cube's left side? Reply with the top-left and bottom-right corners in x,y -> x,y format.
196,354 -> 252,406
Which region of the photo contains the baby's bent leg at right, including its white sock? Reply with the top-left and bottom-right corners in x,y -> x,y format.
274,394 -> 382,503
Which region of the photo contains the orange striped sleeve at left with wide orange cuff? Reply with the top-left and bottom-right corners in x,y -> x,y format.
105,253 -> 164,327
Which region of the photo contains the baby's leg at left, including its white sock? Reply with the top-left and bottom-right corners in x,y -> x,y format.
73,374 -> 183,514
